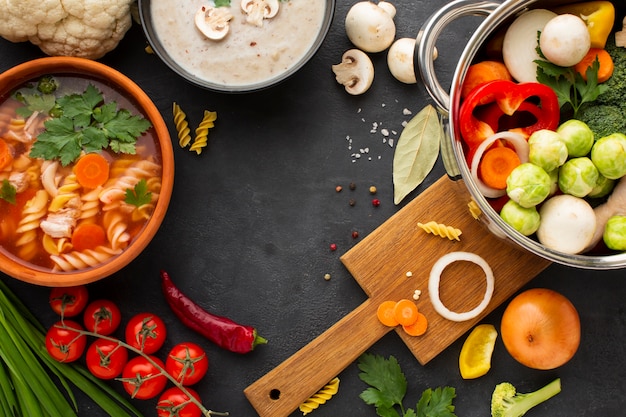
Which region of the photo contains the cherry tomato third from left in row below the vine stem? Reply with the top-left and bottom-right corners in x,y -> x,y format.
121,356 -> 168,400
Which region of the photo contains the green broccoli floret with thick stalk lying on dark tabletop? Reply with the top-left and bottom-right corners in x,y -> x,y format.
491,378 -> 561,417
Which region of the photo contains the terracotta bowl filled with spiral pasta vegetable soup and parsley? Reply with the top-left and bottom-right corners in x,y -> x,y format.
0,57 -> 174,286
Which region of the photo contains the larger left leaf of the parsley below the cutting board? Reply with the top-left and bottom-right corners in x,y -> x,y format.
358,353 -> 407,417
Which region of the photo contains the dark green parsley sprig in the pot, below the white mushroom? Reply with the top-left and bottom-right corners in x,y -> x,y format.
535,37 -> 608,117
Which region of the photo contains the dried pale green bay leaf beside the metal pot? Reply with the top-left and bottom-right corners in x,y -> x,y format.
393,104 -> 443,205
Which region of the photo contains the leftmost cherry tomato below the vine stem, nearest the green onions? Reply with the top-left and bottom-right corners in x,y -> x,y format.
46,320 -> 87,362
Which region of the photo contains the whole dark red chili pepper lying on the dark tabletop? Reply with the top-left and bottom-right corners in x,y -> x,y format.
161,271 -> 267,353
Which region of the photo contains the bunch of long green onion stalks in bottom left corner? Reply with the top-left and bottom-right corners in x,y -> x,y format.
0,280 -> 142,417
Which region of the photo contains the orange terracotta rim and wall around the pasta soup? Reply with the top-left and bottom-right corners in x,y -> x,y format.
0,57 -> 174,286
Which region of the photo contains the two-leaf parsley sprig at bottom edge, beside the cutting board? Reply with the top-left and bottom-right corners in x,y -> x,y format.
358,353 -> 456,417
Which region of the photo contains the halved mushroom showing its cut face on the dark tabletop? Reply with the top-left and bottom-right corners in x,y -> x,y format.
333,49 -> 374,95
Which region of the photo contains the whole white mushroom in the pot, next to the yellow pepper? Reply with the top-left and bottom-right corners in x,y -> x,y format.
539,14 -> 591,67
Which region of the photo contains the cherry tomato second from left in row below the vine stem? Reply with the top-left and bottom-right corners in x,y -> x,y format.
85,339 -> 128,379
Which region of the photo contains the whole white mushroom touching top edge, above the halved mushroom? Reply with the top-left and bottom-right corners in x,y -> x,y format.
345,1 -> 396,52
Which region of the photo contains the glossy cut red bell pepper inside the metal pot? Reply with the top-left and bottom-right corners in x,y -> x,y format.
459,80 -> 561,149
